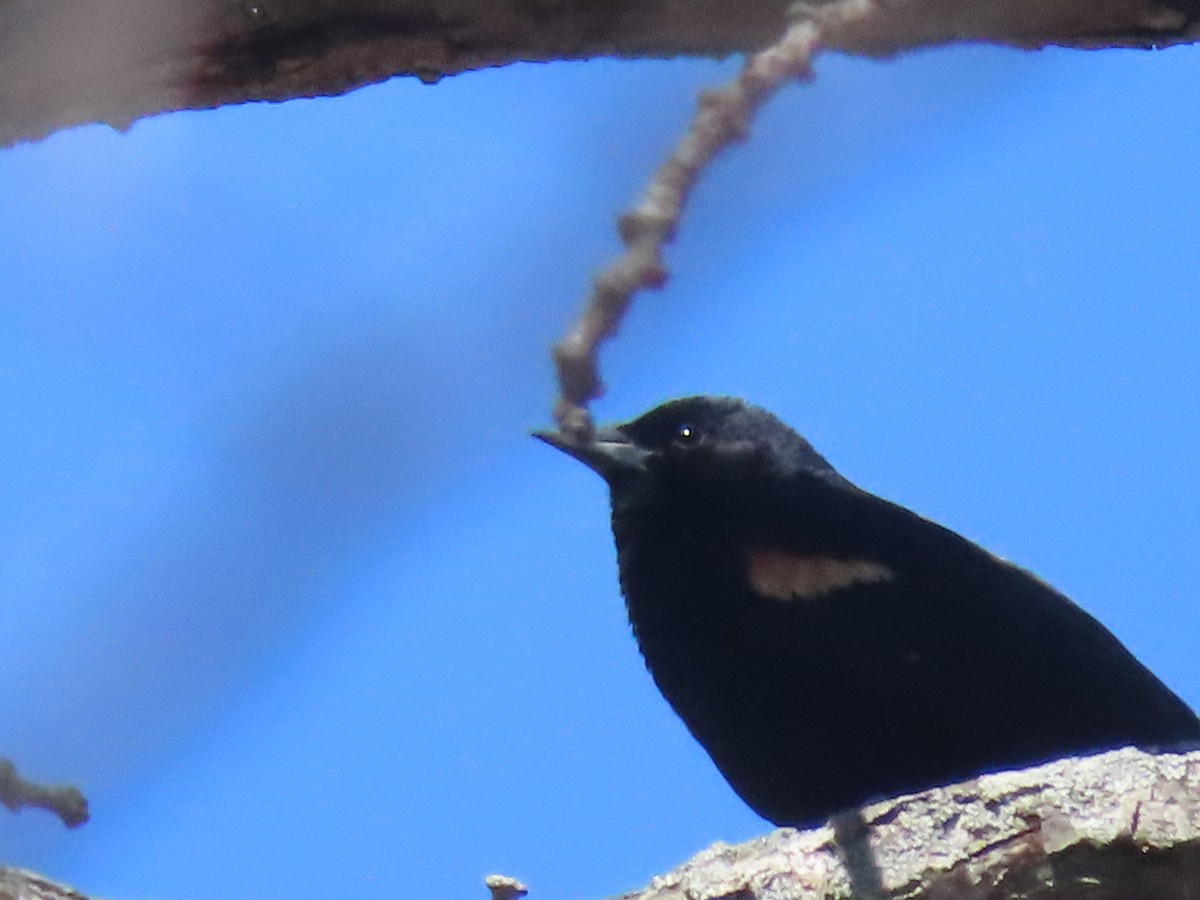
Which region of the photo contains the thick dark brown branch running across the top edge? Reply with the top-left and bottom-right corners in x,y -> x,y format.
0,0 -> 1200,146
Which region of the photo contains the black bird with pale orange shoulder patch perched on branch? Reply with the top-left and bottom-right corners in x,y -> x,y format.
538,397 -> 1200,826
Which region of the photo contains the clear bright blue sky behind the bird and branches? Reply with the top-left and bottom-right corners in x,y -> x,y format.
0,47 -> 1200,900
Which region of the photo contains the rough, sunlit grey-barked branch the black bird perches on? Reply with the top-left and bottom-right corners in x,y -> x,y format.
614,749 -> 1200,900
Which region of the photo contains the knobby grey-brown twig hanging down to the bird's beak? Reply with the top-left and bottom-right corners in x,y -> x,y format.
553,0 -> 872,438
